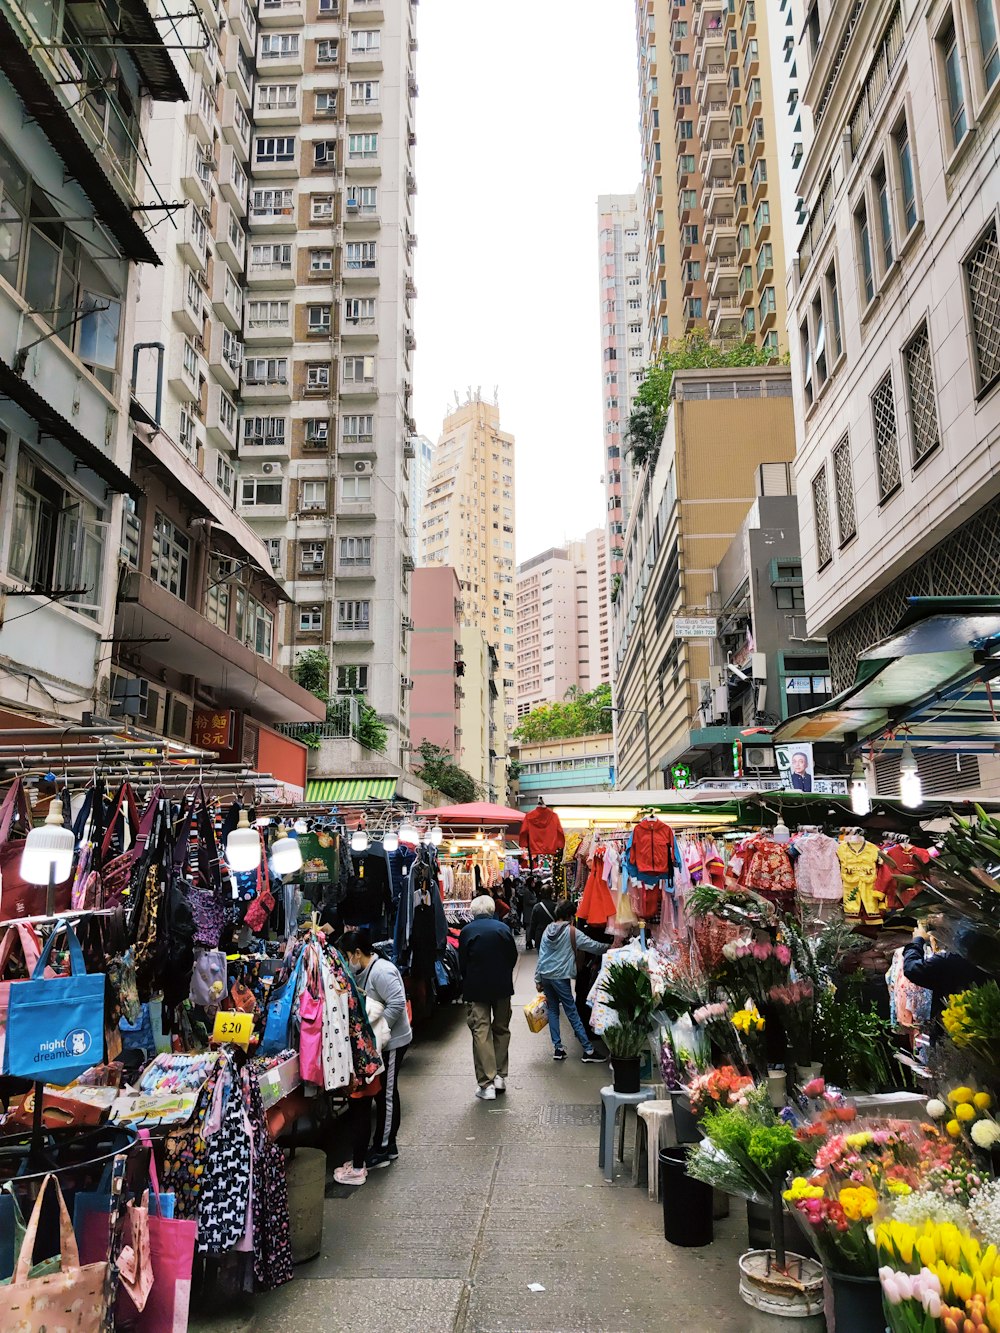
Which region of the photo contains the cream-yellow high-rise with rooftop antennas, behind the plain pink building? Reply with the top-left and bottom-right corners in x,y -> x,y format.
420,395 -> 516,734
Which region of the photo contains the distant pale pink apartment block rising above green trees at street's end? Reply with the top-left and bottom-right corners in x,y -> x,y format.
517,528 -> 611,717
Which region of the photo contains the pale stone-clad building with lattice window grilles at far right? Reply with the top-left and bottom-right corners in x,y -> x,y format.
791,0 -> 1000,762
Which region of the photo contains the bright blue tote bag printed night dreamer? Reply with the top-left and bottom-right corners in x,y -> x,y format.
3,921 -> 104,1086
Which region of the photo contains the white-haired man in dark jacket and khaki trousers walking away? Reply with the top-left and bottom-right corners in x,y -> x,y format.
459,894 -> 517,1101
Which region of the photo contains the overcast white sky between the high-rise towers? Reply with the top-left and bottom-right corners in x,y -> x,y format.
413,0 -> 640,561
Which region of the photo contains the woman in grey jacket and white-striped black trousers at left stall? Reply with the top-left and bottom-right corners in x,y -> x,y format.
340,929 -> 413,1184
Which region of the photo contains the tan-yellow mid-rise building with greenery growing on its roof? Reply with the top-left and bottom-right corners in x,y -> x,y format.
612,367 -> 795,789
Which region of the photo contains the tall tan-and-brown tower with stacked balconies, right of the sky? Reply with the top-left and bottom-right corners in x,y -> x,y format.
636,0 -> 801,355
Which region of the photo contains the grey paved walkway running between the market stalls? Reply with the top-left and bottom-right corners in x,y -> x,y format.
192,954 -> 747,1333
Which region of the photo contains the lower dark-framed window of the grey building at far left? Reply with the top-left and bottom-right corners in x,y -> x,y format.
8,447 -> 105,620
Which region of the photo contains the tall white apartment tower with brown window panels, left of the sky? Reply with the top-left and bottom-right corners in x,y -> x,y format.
230,0 -> 417,761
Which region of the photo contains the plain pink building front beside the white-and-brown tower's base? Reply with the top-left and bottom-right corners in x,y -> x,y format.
409,565 -> 463,758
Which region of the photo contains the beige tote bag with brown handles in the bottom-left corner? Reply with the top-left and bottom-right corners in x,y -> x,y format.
0,1174 -> 108,1333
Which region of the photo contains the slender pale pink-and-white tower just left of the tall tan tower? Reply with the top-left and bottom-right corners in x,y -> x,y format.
597,195 -> 648,575
